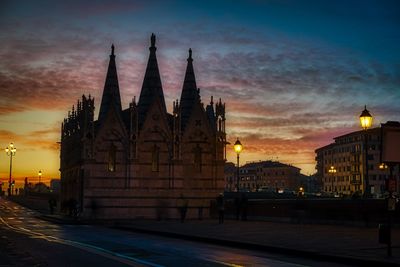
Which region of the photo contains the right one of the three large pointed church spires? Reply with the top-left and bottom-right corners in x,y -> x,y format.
180,48 -> 200,132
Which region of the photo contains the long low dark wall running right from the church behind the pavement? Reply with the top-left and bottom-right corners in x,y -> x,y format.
216,198 -> 400,225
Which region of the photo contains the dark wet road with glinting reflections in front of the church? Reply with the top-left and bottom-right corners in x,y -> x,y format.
0,199 -> 350,267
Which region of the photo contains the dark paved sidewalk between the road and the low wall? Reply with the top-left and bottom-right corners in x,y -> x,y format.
113,220 -> 400,266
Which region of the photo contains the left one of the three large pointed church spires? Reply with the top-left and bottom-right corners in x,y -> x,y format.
99,44 -> 122,121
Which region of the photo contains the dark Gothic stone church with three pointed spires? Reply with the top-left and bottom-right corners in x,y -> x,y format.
60,34 -> 226,219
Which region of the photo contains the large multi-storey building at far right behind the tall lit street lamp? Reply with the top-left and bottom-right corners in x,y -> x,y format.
315,124 -> 399,197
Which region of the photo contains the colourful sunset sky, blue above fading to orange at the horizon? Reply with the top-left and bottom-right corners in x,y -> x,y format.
0,0 -> 400,187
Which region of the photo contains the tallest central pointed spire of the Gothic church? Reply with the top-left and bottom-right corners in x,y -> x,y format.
138,33 -> 167,128
